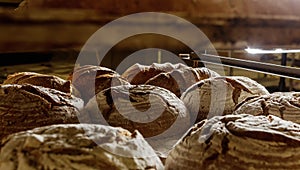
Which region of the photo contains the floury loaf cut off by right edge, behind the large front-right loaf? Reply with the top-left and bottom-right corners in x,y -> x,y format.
234,92 -> 300,123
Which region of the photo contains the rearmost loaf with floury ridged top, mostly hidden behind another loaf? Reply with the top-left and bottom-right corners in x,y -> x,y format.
122,63 -> 188,85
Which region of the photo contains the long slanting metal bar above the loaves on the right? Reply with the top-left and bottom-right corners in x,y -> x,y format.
182,53 -> 300,80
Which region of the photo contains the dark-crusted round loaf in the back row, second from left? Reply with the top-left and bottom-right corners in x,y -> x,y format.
69,65 -> 129,103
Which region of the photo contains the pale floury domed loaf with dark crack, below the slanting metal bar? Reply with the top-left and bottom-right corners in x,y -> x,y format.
181,76 -> 269,122
